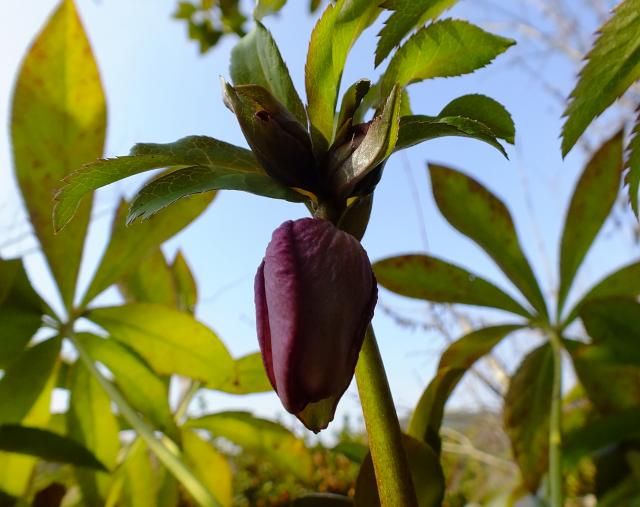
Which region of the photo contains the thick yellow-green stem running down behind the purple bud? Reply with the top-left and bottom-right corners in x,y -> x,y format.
356,325 -> 418,507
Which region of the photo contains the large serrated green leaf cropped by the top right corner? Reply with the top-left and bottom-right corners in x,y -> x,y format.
562,0 -> 640,155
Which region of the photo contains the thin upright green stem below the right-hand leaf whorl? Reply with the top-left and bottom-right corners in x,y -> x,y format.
549,330 -> 564,507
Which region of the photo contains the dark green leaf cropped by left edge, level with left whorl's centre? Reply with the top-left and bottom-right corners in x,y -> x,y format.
0,259 -> 43,369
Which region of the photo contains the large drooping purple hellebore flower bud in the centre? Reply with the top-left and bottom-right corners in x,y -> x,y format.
255,218 -> 378,432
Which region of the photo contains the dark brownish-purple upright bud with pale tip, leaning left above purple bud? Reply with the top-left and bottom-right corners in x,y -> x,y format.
223,83 -> 316,191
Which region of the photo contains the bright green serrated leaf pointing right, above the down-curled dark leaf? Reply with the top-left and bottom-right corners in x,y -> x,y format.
380,19 -> 515,101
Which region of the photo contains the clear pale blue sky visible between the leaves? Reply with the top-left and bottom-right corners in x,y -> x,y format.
0,0 -> 637,436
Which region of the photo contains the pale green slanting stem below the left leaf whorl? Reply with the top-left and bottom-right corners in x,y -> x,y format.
66,332 -> 220,507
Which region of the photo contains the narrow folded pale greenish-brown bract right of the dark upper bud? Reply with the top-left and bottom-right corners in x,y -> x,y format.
332,87 -> 402,196
